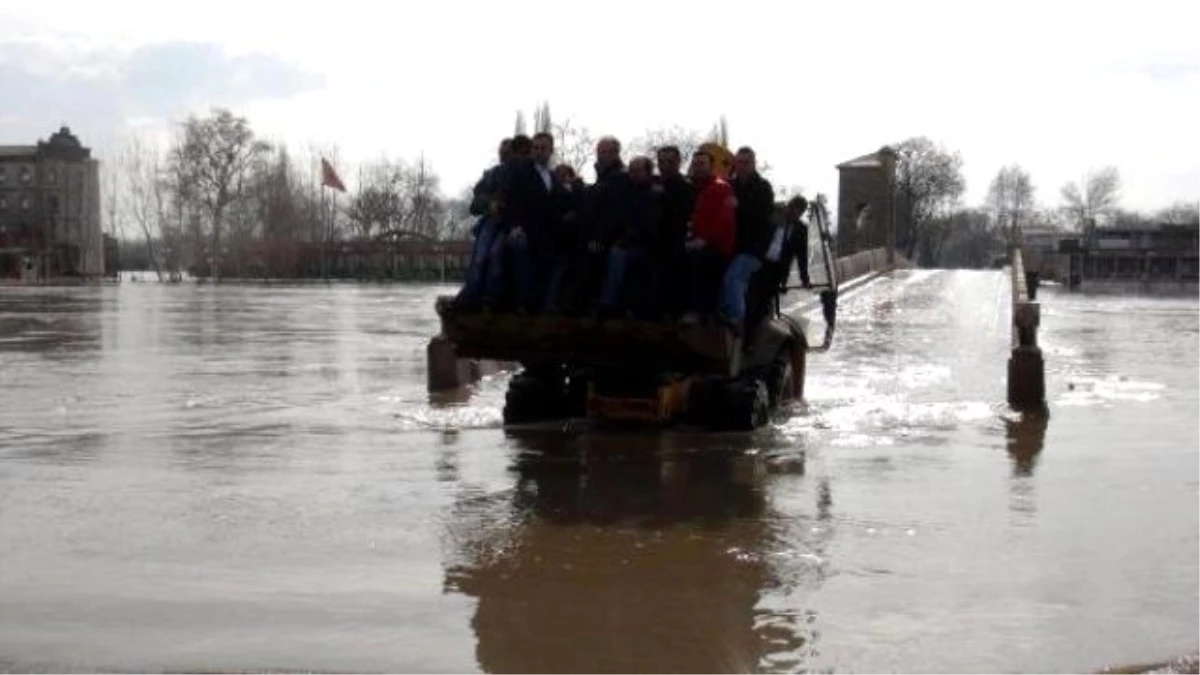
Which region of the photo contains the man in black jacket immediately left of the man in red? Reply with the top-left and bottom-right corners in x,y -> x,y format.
653,145 -> 696,317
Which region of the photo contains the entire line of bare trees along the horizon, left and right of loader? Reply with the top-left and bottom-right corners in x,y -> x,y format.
102,103 -> 1200,279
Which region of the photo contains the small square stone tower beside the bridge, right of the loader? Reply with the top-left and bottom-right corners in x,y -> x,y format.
838,145 -> 896,263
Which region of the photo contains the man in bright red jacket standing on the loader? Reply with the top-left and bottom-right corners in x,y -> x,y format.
683,150 -> 737,323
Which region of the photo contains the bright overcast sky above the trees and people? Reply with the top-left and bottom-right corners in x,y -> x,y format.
0,0 -> 1200,209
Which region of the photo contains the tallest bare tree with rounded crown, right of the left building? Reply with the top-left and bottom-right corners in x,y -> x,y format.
173,108 -> 269,281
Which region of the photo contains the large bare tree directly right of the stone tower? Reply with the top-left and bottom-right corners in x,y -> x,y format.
894,136 -> 966,264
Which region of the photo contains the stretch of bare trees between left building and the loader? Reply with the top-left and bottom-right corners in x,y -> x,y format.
102,109 -> 469,279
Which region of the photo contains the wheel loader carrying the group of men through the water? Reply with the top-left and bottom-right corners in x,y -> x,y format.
436,190 -> 838,431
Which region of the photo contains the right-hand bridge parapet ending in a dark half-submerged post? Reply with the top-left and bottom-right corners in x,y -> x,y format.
1008,247 -> 1046,412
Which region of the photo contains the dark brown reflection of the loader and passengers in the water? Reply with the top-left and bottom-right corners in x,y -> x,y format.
446,432 -> 805,674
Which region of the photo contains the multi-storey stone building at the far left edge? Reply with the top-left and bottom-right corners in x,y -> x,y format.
0,126 -> 104,282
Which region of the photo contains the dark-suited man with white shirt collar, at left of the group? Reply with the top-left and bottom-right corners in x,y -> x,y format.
500,132 -> 565,312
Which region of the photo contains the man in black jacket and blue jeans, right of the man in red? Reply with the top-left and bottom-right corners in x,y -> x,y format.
719,148 -> 775,335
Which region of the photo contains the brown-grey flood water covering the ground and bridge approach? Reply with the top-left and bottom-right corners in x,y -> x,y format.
0,270 -> 1200,674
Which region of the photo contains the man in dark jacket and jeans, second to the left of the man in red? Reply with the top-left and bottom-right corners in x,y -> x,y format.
600,156 -> 662,316
